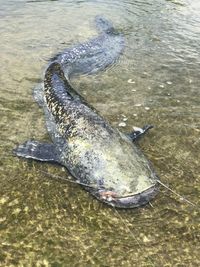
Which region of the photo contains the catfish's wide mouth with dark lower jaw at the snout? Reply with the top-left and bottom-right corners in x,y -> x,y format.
101,183 -> 158,209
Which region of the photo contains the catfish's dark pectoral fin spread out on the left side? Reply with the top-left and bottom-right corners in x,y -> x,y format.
13,140 -> 61,164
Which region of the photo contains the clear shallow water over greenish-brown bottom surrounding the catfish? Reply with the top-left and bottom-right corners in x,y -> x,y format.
0,0 -> 200,267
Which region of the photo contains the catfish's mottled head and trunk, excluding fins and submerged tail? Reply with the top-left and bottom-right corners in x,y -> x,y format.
44,62 -> 157,207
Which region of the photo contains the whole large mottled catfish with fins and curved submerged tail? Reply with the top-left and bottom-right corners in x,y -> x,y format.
14,17 -> 158,208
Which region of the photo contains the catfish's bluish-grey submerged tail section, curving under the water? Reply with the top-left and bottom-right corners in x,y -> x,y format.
53,16 -> 124,77
